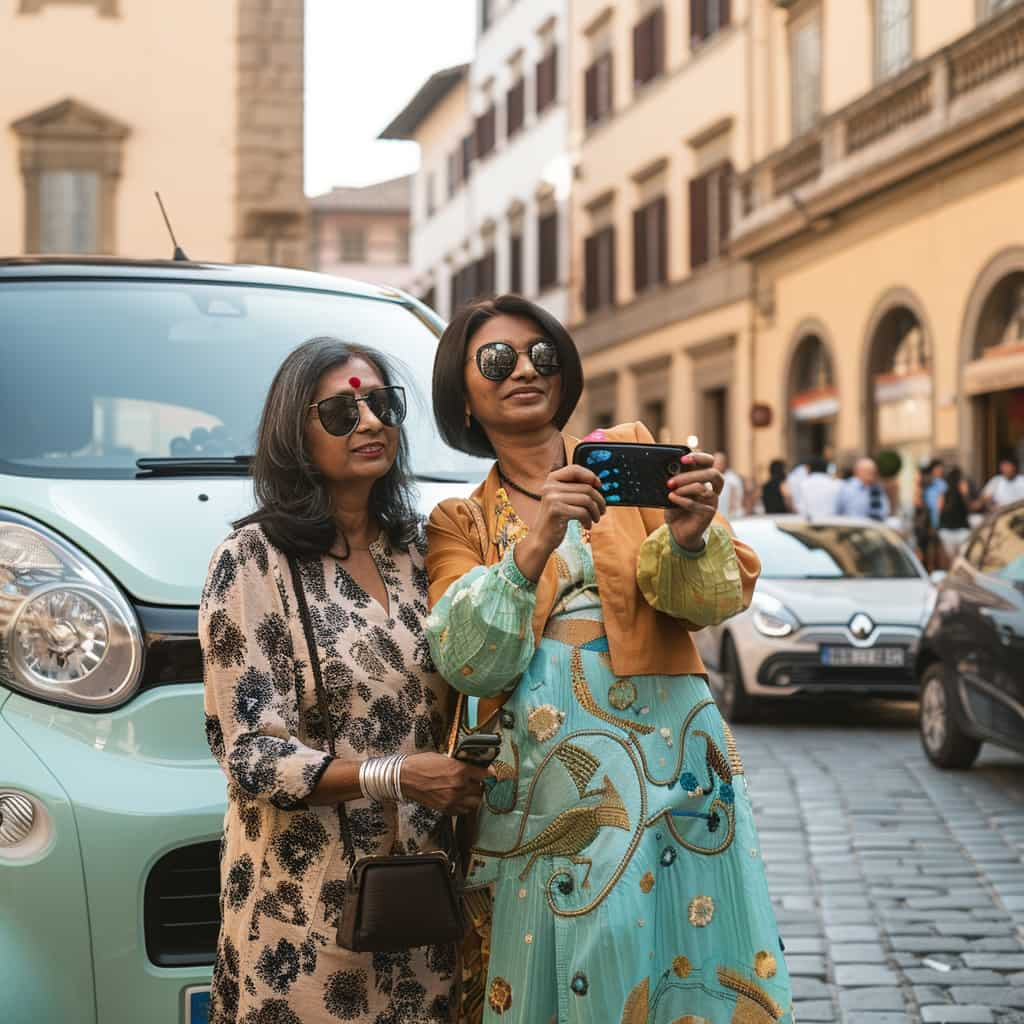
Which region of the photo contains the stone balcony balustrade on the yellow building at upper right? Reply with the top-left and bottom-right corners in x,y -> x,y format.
733,3 -> 1024,255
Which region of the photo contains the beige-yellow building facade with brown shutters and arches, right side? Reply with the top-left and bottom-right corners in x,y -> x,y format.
573,0 -> 1024,498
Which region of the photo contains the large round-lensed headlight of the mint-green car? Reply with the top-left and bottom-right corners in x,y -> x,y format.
0,512 -> 142,711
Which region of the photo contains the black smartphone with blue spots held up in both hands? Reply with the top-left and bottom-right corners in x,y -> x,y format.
572,441 -> 690,509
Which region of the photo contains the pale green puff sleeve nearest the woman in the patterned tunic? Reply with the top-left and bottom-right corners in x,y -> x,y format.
427,546 -> 537,697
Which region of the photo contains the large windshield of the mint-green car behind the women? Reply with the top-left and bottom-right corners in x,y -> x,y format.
0,279 -> 487,480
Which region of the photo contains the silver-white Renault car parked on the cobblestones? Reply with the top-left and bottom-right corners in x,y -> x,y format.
695,515 -> 935,721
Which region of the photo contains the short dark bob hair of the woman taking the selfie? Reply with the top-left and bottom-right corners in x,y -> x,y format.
433,295 -> 583,459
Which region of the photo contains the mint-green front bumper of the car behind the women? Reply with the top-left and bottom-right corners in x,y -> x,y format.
0,684 -> 225,1024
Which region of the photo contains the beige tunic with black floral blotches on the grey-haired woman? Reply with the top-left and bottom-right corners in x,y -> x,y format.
200,526 -> 456,1024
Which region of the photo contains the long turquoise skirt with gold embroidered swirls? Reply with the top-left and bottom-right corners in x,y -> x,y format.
467,616 -> 793,1024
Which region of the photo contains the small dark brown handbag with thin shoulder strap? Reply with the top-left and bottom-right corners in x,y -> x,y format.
288,558 -> 466,953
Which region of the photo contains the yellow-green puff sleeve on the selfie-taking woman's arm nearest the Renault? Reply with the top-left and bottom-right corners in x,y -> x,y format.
637,523 -> 743,627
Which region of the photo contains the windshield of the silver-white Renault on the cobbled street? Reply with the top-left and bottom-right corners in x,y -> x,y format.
734,519 -> 921,580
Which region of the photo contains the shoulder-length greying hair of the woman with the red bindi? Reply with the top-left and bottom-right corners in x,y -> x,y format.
234,338 -> 417,558
